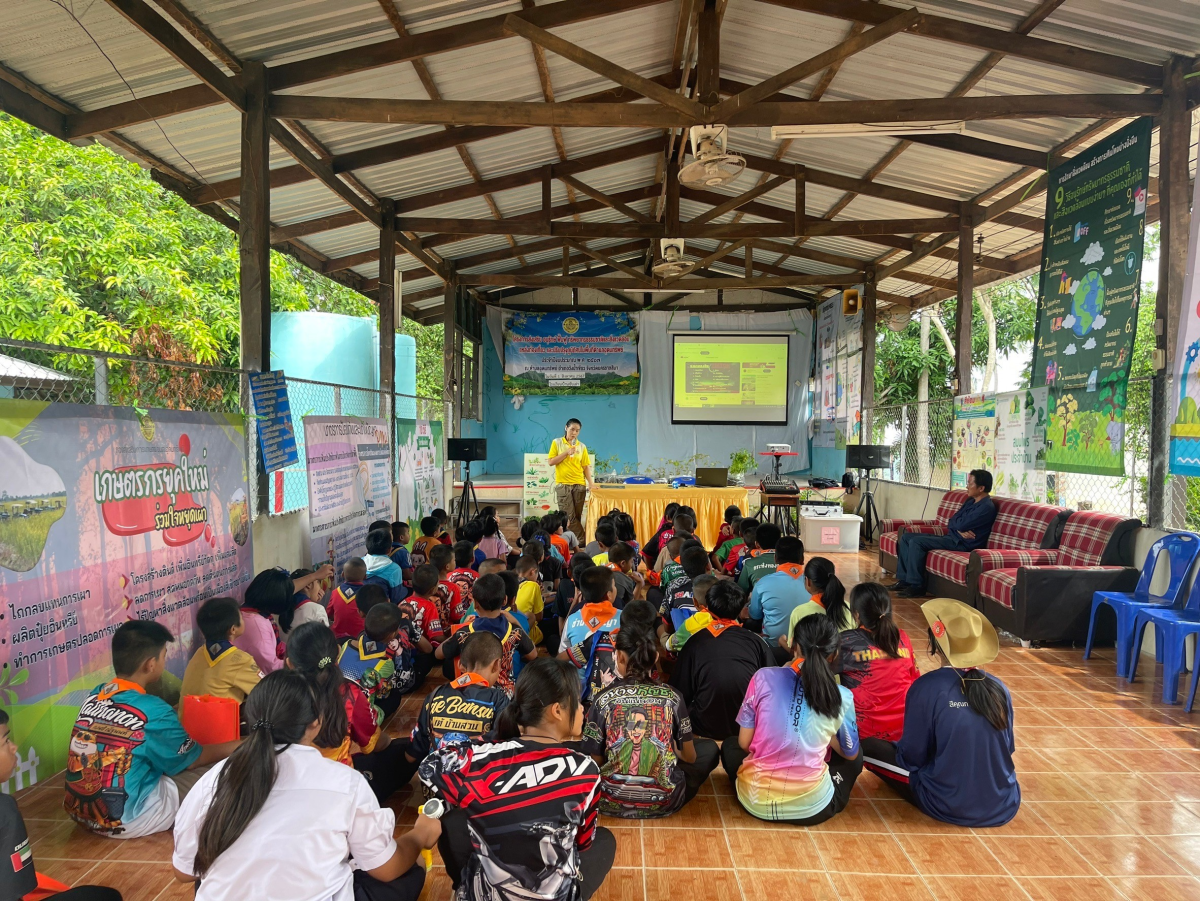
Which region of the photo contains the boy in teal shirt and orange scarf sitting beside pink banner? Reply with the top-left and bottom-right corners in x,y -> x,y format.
62,619 -> 241,839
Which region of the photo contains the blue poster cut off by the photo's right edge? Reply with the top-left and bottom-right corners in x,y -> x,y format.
1170,170 -> 1200,475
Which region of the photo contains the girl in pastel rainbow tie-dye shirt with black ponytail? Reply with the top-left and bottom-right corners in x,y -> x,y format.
721,613 -> 863,825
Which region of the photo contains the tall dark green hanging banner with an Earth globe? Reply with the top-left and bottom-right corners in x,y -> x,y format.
1033,118 -> 1151,475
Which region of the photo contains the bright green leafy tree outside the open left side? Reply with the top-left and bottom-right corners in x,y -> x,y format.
0,114 -> 442,397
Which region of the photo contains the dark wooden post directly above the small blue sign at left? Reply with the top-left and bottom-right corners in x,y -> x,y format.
238,62 -> 271,513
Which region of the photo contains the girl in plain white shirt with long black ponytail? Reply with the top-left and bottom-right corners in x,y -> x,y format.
172,671 -> 440,901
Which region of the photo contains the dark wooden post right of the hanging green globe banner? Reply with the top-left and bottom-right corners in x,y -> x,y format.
1146,56 -> 1190,529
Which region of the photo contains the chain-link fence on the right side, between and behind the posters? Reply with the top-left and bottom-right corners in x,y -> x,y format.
871,377 -> 1200,528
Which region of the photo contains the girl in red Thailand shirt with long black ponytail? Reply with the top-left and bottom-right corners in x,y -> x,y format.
834,582 -> 920,741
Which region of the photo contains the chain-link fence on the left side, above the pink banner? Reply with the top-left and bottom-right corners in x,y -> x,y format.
0,338 -> 449,515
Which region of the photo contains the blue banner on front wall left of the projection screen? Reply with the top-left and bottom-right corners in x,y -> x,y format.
504,311 -> 638,395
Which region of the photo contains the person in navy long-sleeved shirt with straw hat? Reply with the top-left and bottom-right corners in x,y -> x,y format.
863,597 -> 1021,827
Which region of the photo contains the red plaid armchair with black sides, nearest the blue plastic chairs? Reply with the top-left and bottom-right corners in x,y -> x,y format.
970,511 -> 1141,642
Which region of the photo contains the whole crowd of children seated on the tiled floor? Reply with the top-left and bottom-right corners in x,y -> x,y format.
35,504 -> 1020,901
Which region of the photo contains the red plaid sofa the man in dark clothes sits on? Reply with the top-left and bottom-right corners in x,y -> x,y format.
880,492 -> 1068,605
